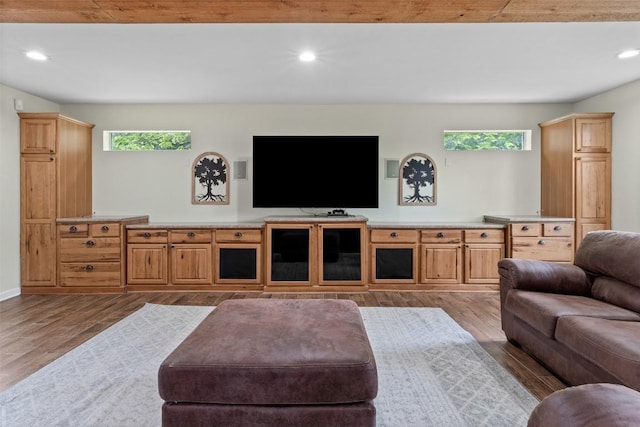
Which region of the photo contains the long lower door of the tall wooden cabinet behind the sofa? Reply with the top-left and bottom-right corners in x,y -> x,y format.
576,154 -> 611,248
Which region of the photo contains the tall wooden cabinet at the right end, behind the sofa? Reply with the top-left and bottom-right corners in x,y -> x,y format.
540,113 -> 614,250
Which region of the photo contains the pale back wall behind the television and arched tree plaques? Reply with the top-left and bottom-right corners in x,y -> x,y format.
63,104 -> 571,222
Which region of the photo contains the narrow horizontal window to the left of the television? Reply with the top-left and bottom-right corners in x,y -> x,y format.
103,130 -> 191,151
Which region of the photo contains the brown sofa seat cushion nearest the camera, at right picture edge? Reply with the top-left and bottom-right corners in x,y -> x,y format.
556,316 -> 640,390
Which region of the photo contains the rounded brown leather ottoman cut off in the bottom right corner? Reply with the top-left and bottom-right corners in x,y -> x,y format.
527,383 -> 640,427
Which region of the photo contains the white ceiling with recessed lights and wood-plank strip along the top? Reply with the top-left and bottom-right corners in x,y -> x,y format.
0,0 -> 640,104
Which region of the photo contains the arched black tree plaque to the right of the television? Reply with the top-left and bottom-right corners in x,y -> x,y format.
398,153 -> 437,206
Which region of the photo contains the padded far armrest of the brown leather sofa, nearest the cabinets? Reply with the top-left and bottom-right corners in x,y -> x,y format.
498,258 -> 591,304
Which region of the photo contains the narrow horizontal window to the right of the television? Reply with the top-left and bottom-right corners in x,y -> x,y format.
444,130 -> 531,151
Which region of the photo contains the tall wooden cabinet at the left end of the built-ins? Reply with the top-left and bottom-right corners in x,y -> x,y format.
18,113 -> 93,293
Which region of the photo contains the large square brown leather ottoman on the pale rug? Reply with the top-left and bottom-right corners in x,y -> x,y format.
158,299 -> 378,427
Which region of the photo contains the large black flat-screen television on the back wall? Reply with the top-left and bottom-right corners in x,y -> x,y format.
253,136 -> 379,209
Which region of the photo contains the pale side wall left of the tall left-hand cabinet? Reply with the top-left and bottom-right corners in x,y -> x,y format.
0,85 -> 60,301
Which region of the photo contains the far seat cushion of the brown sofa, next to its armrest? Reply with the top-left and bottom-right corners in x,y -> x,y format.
505,290 -> 640,338
